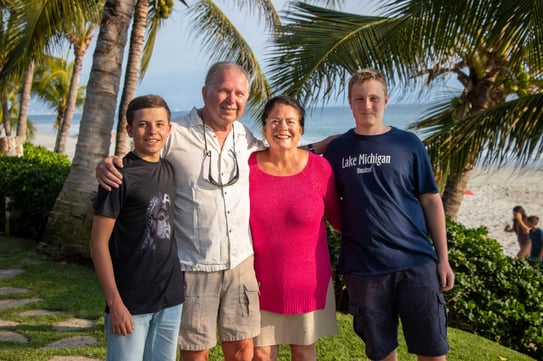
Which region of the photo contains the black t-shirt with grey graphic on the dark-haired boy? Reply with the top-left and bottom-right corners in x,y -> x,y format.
95,152 -> 184,314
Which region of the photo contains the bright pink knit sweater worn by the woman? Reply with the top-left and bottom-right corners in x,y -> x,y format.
249,153 -> 341,314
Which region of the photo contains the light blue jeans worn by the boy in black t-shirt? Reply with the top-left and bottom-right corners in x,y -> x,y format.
104,304 -> 183,361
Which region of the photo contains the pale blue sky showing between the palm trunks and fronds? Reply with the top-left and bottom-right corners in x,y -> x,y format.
30,0 -> 448,113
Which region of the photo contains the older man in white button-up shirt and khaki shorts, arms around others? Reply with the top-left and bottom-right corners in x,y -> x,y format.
96,62 -> 336,361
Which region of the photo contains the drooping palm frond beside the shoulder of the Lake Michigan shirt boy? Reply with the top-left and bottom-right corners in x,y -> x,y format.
411,94 -> 543,183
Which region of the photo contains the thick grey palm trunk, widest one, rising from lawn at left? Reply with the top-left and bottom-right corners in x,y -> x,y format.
38,0 -> 136,258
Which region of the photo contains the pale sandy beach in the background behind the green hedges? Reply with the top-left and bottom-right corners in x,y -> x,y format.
32,129 -> 543,257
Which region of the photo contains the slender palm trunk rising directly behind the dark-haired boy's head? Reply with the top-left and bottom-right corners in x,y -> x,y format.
115,0 -> 149,157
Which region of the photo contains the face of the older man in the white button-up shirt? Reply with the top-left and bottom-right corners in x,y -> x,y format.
202,66 -> 249,130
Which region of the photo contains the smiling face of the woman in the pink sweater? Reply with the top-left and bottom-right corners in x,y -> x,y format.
264,103 -> 303,150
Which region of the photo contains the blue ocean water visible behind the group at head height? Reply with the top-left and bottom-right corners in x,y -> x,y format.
29,104 -> 425,144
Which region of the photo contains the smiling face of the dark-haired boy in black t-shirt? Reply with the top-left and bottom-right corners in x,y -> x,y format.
126,108 -> 172,162
